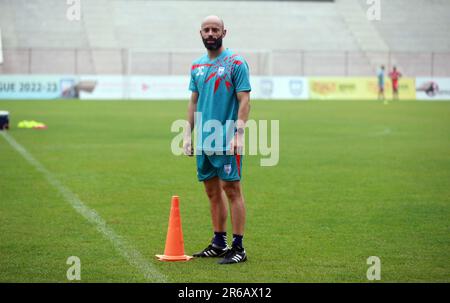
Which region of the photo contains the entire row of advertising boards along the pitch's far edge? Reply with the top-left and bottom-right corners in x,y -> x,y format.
0,75 -> 428,100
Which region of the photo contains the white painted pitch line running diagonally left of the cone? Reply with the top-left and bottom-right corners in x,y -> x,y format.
0,131 -> 167,282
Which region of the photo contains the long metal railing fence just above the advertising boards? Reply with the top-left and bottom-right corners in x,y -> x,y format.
0,48 -> 450,77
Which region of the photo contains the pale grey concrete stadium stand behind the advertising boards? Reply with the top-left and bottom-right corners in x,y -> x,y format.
0,0 -> 450,76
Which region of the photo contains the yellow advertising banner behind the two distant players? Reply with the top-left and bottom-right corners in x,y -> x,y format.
309,77 -> 416,100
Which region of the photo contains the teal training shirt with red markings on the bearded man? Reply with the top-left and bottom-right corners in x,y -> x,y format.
189,49 -> 251,154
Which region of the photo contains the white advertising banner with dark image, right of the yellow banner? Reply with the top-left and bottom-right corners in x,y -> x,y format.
416,78 -> 450,101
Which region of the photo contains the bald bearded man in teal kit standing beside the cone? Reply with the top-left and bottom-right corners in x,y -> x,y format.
184,16 -> 251,264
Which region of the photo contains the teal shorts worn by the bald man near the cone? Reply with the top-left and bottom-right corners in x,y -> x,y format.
197,153 -> 242,181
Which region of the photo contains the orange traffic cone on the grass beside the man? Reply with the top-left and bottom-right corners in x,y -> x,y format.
156,196 -> 192,261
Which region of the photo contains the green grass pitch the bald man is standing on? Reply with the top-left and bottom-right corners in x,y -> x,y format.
0,101 -> 450,282
